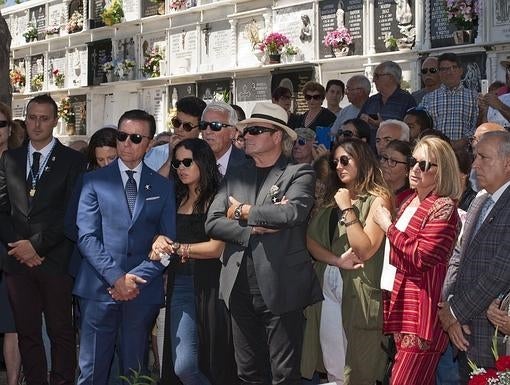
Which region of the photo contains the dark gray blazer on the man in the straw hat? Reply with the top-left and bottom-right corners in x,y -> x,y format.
206,156 -> 323,314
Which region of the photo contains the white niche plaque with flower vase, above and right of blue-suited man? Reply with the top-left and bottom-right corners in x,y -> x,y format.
139,32 -> 167,79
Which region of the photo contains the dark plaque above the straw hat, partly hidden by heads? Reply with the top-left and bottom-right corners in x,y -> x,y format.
271,67 -> 314,113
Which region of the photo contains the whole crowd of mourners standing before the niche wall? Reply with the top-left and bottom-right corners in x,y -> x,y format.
0,49 -> 510,385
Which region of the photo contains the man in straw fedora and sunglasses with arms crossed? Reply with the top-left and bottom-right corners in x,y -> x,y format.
206,102 -> 322,384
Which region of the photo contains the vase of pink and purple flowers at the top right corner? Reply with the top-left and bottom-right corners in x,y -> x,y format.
445,0 -> 480,44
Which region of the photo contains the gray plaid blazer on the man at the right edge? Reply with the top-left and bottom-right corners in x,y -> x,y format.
446,188 -> 510,367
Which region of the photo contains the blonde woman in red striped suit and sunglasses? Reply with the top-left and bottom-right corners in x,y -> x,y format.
374,136 -> 462,385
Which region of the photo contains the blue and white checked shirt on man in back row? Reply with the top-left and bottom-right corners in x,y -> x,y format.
420,84 -> 478,140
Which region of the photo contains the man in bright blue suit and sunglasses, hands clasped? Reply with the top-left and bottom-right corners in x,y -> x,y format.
74,110 -> 175,385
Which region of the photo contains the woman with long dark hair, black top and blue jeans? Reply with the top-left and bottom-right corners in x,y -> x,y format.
152,139 -> 235,385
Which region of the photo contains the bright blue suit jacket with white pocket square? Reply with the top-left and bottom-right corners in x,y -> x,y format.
74,161 -> 175,304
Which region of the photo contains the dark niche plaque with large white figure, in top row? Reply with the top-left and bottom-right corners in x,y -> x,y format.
374,0 -> 416,52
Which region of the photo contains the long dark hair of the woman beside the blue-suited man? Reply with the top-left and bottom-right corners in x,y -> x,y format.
170,138 -> 221,213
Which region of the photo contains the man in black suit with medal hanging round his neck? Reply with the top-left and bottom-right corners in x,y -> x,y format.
0,95 -> 85,385
